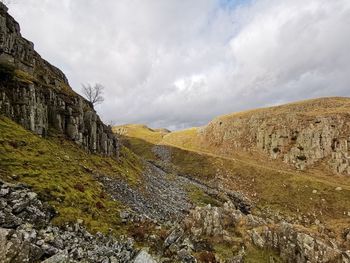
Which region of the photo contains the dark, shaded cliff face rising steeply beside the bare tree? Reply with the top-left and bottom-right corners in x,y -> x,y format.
0,3 -> 119,156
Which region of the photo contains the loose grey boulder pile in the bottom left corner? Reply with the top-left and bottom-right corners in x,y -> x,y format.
0,181 -> 152,263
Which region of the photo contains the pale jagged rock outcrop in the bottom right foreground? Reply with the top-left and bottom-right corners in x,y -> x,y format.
178,202 -> 350,263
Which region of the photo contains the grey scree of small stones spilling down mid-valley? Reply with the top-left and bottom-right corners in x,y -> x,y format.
97,163 -> 206,222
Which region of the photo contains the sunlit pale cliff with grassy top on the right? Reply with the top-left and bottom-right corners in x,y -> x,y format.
201,98 -> 350,175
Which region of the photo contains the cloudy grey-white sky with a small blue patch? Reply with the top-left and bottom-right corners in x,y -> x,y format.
6,0 -> 350,129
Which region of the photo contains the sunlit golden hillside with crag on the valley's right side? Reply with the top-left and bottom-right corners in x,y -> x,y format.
113,98 -> 350,262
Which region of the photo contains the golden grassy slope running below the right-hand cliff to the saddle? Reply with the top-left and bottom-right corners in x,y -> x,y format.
113,110 -> 350,227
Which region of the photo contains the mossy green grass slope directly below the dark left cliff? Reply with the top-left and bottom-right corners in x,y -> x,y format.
0,115 -> 142,232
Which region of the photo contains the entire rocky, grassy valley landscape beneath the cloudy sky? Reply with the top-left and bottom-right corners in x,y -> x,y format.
0,2 -> 350,263
